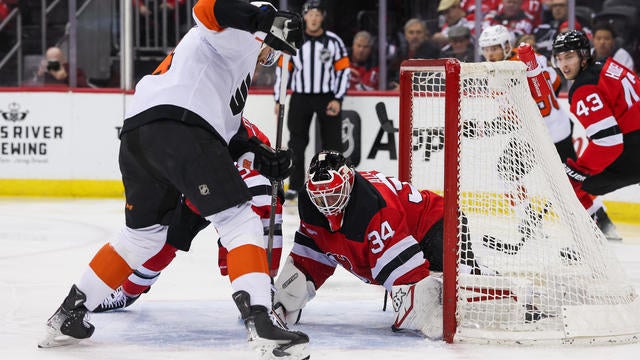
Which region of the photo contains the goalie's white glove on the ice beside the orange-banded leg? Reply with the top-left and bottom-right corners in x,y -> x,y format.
273,257 -> 316,324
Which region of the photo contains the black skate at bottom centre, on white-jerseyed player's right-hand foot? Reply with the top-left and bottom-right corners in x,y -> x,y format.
233,291 -> 310,360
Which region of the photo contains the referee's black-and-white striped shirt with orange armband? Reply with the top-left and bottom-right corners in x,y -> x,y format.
274,30 -> 350,102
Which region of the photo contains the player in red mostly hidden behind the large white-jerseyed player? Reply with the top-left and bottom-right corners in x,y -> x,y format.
93,118 -> 283,312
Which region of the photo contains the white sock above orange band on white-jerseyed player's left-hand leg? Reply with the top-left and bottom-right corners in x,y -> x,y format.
111,224 -> 168,269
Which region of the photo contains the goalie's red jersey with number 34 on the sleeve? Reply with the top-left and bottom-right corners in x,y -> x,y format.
291,171 -> 443,291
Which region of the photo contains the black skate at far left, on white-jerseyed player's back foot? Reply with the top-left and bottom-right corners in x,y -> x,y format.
38,285 -> 95,348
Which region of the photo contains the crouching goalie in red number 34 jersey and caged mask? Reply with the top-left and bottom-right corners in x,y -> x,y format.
274,151 -> 480,338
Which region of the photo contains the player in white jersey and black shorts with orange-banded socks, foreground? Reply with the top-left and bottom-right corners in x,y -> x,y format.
39,0 -> 309,359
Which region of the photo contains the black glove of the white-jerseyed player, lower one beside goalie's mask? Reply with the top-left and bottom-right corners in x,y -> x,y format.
249,137 -> 293,181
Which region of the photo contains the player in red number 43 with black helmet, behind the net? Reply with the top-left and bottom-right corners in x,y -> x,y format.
552,30 -> 640,239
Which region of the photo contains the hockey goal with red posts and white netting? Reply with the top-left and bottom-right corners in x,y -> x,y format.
398,59 -> 640,344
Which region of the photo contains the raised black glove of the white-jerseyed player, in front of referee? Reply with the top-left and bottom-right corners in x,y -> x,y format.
264,11 -> 303,56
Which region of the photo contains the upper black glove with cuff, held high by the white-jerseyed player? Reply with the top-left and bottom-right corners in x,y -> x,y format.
252,1 -> 303,56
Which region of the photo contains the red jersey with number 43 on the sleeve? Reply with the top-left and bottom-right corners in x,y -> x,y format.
569,58 -> 640,175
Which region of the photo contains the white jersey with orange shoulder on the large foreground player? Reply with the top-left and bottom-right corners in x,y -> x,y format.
123,6 -> 266,144
